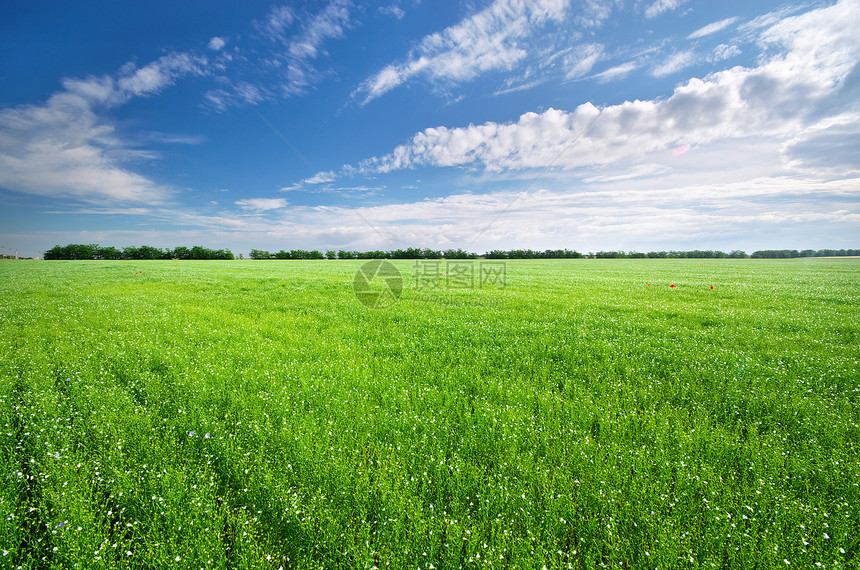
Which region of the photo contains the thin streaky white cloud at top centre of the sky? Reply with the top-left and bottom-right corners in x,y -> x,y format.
352,0 -> 568,103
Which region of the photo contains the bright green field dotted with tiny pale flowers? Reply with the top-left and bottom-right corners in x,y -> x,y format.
0,259 -> 860,570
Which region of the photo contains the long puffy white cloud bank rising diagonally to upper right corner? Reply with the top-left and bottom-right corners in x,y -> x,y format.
352,1 -> 860,178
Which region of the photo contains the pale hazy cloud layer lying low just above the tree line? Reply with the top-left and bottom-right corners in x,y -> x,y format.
200,172 -> 860,252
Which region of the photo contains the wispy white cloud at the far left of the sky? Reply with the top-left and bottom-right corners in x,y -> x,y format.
0,53 -> 207,203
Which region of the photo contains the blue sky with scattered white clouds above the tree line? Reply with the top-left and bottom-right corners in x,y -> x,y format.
0,0 -> 860,256
